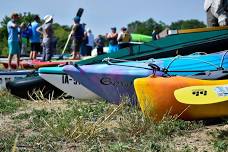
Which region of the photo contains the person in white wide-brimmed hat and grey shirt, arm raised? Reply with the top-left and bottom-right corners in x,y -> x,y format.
36,15 -> 54,61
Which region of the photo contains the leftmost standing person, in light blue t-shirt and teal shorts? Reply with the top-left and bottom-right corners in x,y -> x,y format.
7,13 -> 20,69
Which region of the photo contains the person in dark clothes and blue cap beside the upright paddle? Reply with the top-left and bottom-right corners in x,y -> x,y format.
70,16 -> 85,59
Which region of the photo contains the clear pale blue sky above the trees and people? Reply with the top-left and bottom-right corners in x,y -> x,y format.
0,0 -> 206,34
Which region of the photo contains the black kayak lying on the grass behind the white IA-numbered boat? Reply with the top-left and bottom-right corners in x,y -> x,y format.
6,76 -> 64,99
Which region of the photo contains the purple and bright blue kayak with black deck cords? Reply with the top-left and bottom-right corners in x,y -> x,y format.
63,51 -> 228,105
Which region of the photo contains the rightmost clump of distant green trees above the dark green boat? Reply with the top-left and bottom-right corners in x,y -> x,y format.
170,19 -> 206,30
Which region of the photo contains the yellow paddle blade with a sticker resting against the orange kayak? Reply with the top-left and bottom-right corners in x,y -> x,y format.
174,84 -> 228,105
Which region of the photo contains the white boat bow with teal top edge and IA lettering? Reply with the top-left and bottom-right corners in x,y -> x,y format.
38,67 -> 99,99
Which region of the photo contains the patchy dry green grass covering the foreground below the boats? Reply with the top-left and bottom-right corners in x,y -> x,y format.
0,92 -> 227,152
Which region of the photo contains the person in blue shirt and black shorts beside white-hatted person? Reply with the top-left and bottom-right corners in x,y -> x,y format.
30,15 -> 41,60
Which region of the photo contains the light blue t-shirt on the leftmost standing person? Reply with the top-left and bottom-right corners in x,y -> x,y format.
7,20 -> 18,42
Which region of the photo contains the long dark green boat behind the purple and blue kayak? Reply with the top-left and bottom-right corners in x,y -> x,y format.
72,27 -> 228,65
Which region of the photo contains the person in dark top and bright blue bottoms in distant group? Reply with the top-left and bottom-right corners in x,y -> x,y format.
106,27 -> 119,53
